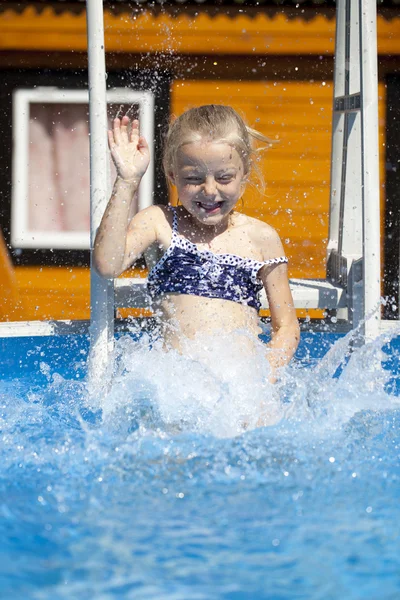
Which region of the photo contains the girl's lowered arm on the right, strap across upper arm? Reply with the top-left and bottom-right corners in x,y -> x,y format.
260,225 -> 300,380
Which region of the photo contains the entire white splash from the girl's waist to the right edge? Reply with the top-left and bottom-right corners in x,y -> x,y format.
92,331 -> 398,437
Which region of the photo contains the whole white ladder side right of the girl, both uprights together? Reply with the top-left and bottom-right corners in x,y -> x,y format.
327,0 -> 381,338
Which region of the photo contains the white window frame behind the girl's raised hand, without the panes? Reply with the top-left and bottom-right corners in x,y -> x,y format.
11,87 -> 154,250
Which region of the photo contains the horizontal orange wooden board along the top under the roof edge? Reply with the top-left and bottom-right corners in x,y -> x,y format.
0,3 -> 400,55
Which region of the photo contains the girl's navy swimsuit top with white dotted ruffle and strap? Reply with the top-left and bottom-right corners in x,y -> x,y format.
147,208 -> 288,310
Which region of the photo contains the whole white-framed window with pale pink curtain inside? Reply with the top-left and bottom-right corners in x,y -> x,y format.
11,87 -> 154,250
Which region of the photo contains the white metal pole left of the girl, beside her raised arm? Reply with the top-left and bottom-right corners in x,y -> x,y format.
86,0 -> 114,391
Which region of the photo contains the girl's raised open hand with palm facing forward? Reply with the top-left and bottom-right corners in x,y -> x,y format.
108,116 -> 150,180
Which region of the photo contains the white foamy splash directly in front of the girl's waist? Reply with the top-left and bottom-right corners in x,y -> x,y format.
100,332 -> 281,437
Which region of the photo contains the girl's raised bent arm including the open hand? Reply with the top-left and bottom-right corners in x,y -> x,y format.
93,117 -> 159,277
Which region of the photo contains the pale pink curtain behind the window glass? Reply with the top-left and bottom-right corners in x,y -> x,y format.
28,103 -> 90,231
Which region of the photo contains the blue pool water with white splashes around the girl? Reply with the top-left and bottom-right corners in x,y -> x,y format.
0,326 -> 400,600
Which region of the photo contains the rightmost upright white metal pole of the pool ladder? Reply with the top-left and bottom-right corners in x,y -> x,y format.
359,0 -> 381,339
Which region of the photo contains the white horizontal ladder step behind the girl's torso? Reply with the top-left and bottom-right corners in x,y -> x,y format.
114,277 -> 347,309
